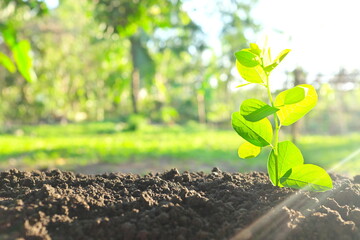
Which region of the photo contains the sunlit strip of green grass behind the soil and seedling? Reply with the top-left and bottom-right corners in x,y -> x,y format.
0,122 -> 360,174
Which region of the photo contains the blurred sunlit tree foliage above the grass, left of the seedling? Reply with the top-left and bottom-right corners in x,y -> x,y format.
0,0 -> 330,129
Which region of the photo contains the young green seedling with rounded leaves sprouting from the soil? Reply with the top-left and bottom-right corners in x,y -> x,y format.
231,43 -> 332,192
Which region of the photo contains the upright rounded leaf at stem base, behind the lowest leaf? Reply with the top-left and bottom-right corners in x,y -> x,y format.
267,141 -> 304,187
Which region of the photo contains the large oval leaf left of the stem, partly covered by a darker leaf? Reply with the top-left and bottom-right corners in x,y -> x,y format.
231,112 -> 273,147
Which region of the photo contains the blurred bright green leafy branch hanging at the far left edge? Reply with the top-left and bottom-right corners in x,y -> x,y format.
0,0 -> 48,124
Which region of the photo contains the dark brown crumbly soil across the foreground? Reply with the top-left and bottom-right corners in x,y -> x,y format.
0,168 -> 360,240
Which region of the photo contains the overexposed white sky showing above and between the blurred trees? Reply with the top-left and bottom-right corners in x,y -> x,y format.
185,0 -> 360,81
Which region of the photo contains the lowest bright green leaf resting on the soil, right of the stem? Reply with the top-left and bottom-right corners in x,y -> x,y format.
280,164 -> 333,192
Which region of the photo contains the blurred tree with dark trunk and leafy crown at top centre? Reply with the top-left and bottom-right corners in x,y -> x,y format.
96,0 -> 198,113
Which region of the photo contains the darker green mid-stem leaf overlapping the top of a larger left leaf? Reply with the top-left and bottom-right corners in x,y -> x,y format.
240,98 -> 279,122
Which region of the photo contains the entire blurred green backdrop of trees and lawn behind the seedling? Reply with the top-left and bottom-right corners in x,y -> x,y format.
0,0 -> 360,175
